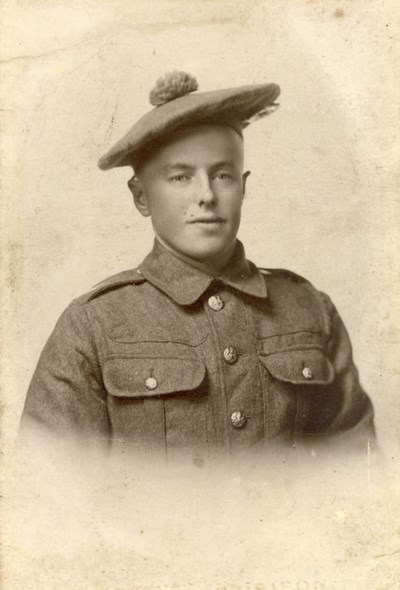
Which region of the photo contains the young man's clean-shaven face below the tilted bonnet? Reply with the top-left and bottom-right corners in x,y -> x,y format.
131,125 -> 244,266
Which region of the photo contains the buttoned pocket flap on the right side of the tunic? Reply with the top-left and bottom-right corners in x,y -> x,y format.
260,349 -> 334,385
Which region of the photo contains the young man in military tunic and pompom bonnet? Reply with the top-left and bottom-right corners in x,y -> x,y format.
19,72 -> 373,457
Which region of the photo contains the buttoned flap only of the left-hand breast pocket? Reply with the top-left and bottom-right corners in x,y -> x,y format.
103,358 -> 206,397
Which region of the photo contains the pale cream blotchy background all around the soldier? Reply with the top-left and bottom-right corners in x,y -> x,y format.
0,0 -> 400,590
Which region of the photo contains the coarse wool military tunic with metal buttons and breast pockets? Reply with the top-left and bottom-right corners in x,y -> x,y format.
22,240 -> 373,455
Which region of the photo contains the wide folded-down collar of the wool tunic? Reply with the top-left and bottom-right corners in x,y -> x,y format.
138,240 -> 267,305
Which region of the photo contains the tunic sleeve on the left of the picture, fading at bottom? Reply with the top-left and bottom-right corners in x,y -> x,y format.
21,302 -> 109,446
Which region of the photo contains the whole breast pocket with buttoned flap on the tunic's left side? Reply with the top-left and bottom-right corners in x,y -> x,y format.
103,352 -> 207,449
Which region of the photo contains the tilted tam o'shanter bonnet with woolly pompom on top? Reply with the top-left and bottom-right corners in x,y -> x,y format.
98,71 -> 280,170
